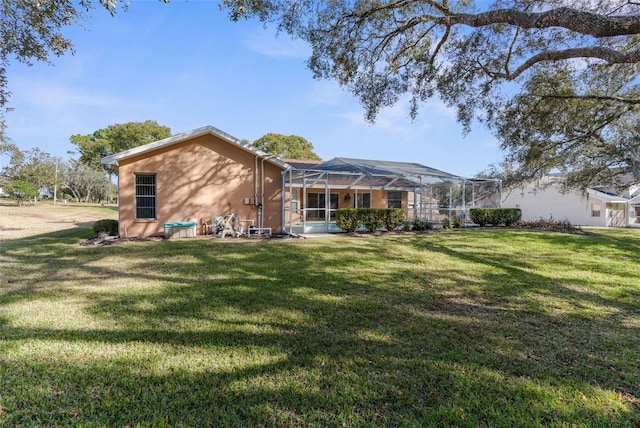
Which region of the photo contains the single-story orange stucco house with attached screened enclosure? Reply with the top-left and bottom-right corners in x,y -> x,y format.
102,126 -> 495,237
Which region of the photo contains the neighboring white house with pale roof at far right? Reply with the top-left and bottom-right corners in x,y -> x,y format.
502,176 -> 640,227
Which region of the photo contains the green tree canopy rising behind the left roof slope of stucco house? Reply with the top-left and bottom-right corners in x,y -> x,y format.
70,120 -> 171,169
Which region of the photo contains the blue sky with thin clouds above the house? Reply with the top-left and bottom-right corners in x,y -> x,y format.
0,0 -> 502,176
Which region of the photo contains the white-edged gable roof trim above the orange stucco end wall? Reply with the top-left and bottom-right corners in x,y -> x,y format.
100,125 -> 290,170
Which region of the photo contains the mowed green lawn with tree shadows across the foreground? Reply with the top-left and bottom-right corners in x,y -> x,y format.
0,226 -> 640,427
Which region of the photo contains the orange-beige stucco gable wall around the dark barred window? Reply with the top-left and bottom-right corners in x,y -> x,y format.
118,135 -> 282,237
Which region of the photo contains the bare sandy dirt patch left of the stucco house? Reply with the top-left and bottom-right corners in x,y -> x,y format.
0,201 -> 118,241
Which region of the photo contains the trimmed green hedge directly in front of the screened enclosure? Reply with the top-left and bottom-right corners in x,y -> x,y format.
336,208 -> 404,232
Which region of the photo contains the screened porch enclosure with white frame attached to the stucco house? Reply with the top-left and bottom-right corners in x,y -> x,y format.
282,158 -> 500,233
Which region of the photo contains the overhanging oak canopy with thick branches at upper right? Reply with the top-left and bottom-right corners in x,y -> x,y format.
222,0 -> 640,186
